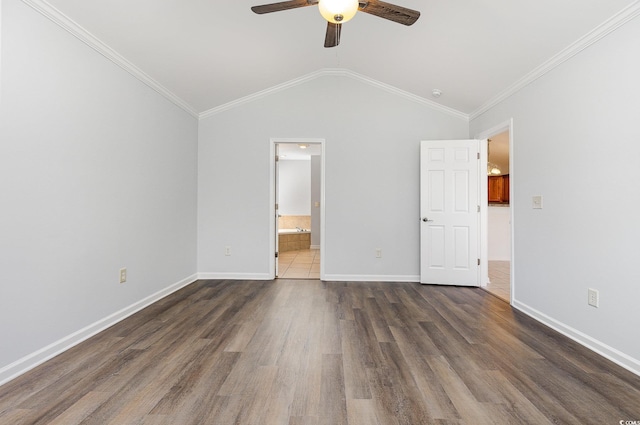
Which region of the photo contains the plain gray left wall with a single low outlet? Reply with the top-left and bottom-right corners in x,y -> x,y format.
0,0 -> 197,382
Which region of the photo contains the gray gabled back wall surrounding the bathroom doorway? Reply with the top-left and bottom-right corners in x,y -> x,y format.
198,76 -> 468,280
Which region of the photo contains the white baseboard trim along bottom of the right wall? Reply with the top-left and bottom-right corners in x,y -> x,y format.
512,300 -> 640,376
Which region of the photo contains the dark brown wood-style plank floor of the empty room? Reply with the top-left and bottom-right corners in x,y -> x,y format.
0,280 -> 640,425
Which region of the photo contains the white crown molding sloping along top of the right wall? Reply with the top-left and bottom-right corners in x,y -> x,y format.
469,0 -> 640,120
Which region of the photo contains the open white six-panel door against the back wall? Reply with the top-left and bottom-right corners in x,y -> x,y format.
420,140 -> 480,286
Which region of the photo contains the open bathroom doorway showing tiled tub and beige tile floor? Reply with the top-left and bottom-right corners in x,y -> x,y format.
271,139 -> 324,279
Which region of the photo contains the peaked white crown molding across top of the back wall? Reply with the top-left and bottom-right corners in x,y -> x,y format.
200,68 -> 469,122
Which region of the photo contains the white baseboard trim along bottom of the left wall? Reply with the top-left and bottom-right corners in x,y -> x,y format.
0,275 -> 197,385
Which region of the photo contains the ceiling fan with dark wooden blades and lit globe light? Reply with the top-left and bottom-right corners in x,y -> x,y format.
251,0 -> 420,47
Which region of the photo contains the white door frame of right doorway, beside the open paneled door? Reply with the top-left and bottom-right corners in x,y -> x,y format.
476,118 -> 517,305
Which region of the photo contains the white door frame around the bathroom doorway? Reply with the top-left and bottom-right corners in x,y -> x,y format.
269,137 -> 326,280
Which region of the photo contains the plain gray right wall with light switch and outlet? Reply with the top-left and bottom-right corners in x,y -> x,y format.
471,13 -> 640,373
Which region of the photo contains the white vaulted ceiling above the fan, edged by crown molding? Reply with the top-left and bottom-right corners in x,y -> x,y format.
41,0 -> 637,114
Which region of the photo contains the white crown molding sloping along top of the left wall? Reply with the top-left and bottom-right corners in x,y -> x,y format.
22,0 -> 198,118
